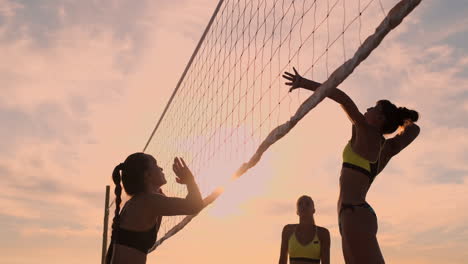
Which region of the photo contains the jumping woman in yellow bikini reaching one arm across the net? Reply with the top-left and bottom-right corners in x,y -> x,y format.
283,68 -> 420,264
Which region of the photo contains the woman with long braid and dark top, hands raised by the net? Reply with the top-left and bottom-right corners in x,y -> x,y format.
106,153 -> 203,264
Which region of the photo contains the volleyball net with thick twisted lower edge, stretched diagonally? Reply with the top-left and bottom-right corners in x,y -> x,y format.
104,0 -> 420,253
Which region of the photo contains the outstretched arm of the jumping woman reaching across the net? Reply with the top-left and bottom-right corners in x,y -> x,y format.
283,68 -> 366,126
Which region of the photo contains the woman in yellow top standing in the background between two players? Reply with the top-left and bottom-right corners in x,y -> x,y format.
279,195 -> 330,264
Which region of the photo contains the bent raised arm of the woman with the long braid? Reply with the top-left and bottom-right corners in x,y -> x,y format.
149,158 -> 203,216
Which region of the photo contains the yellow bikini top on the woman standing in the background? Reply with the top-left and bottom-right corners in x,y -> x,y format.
288,227 -> 320,264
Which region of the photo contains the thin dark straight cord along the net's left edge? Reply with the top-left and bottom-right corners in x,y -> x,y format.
143,0 -> 224,152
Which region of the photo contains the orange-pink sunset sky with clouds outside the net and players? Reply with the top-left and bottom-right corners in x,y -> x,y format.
0,0 -> 468,264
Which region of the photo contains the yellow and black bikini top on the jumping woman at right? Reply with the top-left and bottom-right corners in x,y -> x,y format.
343,141 -> 385,184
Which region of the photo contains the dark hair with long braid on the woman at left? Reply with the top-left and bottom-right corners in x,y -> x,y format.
106,152 -> 149,264
